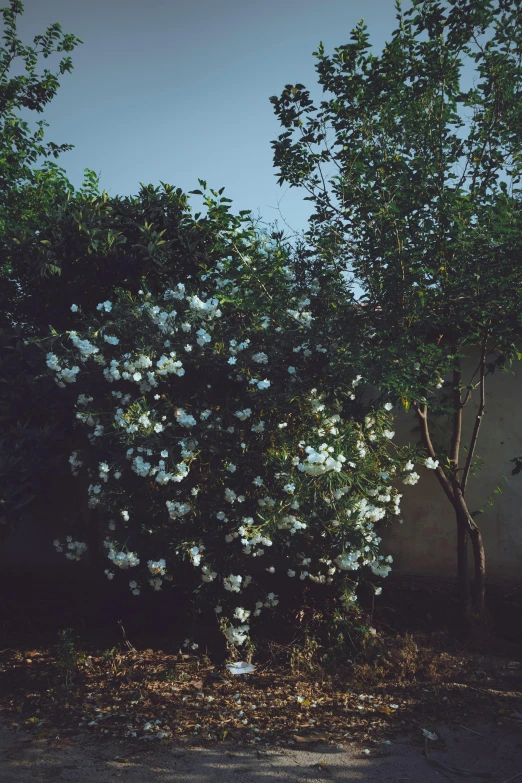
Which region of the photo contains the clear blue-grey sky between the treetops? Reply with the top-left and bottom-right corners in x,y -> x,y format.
12,0 -> 410,243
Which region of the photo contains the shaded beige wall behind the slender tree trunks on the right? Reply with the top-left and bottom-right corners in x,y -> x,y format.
382,350 -> 522,580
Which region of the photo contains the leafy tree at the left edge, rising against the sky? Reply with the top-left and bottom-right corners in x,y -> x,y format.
0,0 -> 81,536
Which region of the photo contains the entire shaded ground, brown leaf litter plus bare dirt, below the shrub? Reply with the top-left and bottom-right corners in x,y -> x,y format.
0,582 -> 522,783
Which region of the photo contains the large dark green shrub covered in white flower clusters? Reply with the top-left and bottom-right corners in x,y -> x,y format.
41,224 -> 417,645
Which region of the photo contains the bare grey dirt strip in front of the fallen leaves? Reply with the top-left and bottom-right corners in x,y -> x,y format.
0,724 -> 522,783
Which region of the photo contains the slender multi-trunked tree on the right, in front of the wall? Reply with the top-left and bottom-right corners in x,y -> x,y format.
270,0 -> 522,621
